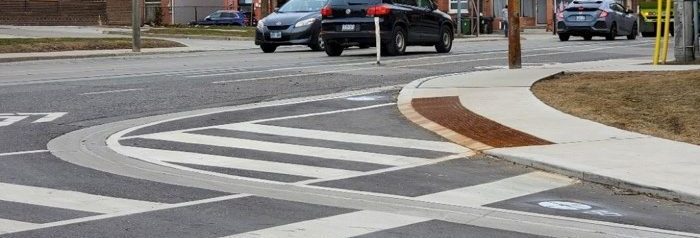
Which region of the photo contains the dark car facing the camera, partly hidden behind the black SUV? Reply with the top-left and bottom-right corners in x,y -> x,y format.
255,0 -> 328,53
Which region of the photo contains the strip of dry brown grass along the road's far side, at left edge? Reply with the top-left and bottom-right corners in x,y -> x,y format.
0,38 -> 184,53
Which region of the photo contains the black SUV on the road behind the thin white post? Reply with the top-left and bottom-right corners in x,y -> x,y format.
321,0 -> 455,56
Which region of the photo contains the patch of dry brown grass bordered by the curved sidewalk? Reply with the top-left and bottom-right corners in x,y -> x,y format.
532,70 -> 700,145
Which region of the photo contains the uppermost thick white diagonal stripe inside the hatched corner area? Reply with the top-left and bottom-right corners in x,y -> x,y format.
214,123 -> 468,154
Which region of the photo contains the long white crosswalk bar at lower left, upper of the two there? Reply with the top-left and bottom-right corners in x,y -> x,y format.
0,183 -> 162,213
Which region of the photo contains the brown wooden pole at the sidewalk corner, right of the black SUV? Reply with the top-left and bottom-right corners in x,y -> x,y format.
508,0 -> 522,69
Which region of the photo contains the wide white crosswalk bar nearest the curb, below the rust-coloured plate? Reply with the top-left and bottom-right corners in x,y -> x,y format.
417,171 -> 576,207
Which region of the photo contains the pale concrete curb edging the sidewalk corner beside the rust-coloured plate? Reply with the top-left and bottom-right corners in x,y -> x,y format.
397,70 -> 700,205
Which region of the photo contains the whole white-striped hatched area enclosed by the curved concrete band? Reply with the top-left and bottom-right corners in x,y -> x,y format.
111,116 -> 469,183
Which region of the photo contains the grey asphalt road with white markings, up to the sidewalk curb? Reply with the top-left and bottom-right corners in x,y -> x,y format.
0,36 -> 700,237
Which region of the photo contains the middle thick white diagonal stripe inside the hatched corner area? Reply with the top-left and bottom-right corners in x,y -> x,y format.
138,132 -> 428,166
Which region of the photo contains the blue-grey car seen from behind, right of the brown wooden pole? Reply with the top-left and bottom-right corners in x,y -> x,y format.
557,0 -> 639,41
